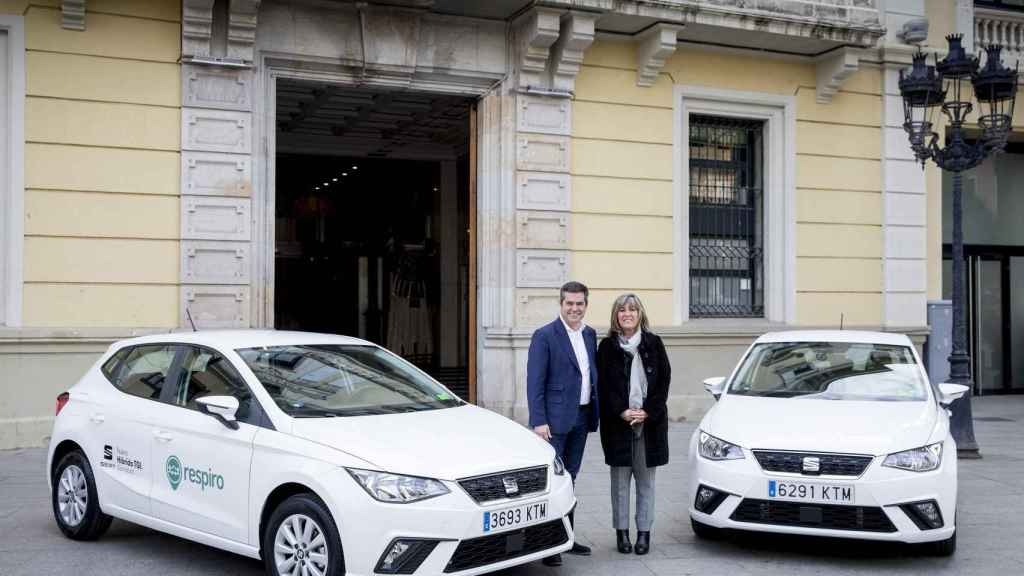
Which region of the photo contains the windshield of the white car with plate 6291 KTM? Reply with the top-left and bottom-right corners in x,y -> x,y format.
728,342 -> 928,402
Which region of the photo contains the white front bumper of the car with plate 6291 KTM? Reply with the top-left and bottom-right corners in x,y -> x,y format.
688,439 -> 956,543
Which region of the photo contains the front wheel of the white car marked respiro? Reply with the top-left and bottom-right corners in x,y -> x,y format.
263,494 -> 345,576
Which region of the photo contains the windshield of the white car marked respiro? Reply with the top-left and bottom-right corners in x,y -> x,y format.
236,345 -> 463,418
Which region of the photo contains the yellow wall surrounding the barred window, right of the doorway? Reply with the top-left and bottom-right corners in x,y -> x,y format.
570,40 -> 883,327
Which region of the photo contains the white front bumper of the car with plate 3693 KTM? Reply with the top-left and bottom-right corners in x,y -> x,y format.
329,471 -> 575,576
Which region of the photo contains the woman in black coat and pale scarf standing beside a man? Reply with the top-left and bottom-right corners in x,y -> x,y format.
597,293 -> 672,554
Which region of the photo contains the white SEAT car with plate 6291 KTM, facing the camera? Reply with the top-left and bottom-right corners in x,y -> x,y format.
689,331 -> 968,556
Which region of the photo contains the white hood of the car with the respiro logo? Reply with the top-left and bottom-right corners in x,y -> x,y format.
292,405 -> 555,480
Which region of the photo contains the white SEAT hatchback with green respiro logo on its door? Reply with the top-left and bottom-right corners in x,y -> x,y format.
47,331 -> 575,576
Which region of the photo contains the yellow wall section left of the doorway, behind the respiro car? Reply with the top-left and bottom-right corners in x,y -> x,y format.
0,0 -> 181,449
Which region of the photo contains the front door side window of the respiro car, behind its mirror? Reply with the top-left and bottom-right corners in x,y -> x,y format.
174,346 -> 258,424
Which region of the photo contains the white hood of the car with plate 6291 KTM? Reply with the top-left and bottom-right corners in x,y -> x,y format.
701,395 -> 937,456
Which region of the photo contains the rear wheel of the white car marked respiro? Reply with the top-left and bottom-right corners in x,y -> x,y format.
50,450 -> 114,540
